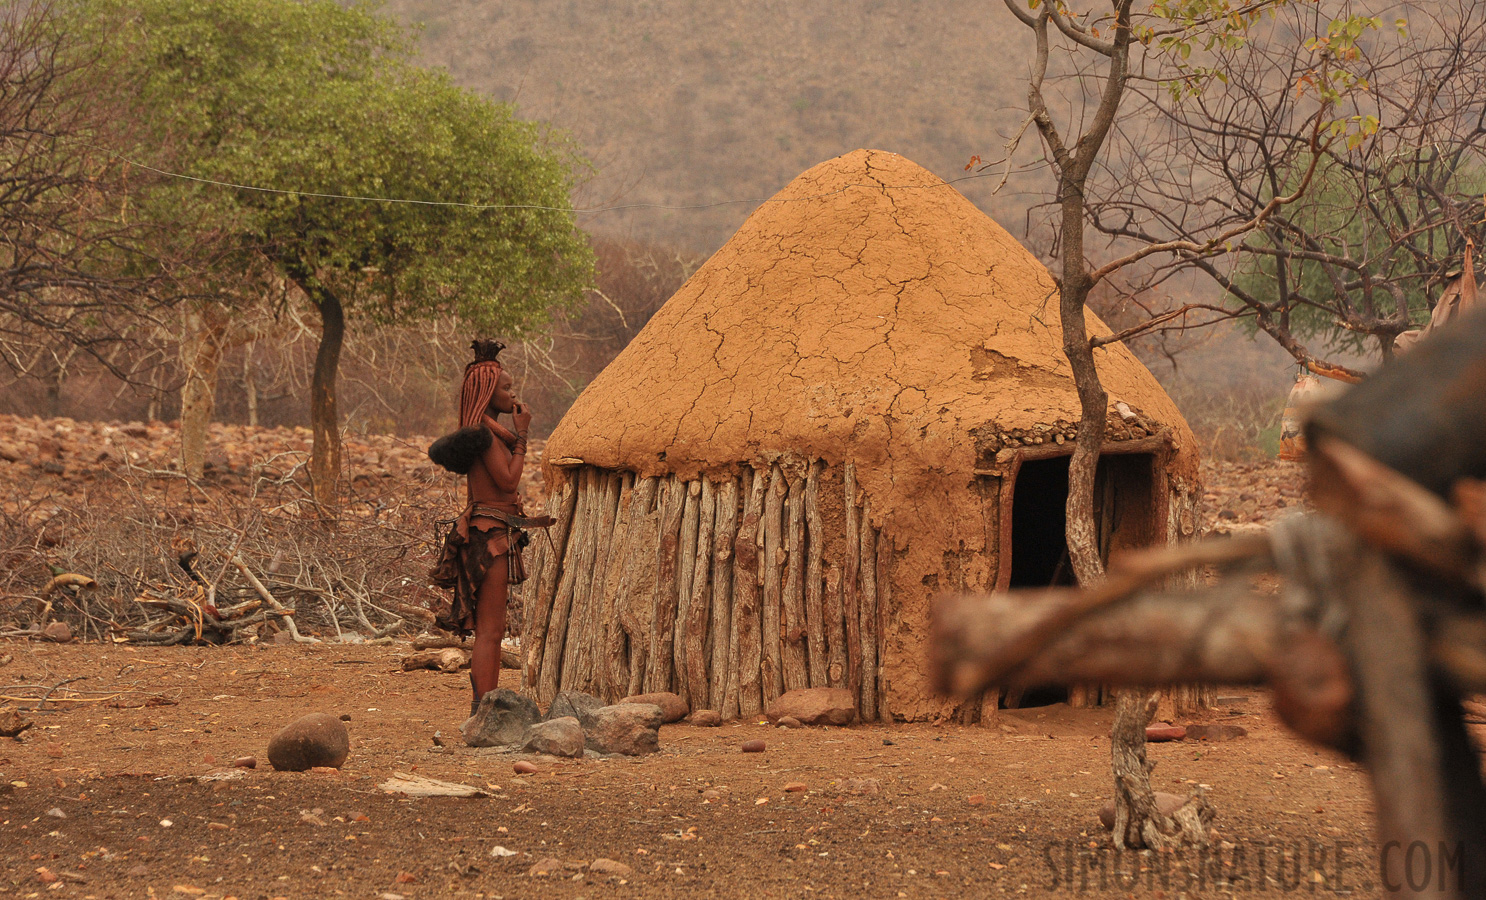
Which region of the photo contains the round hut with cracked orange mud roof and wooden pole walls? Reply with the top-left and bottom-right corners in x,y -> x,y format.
523,150 -> 1196,722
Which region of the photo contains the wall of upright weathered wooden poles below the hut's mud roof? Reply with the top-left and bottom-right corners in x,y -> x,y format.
523,460 -> 892,720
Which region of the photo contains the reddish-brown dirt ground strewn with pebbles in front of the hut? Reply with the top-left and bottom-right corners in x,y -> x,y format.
0,642 -> 1444,900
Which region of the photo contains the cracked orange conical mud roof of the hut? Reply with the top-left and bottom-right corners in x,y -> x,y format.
547,150 -> 1195,490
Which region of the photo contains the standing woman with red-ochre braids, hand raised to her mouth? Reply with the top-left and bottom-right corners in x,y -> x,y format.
428,340 -> 541,716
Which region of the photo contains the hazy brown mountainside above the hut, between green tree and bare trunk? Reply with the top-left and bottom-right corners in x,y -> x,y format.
377,0 -> 1036,252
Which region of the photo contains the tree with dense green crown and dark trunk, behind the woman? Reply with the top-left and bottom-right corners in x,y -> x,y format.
83,0 -> 593,508
